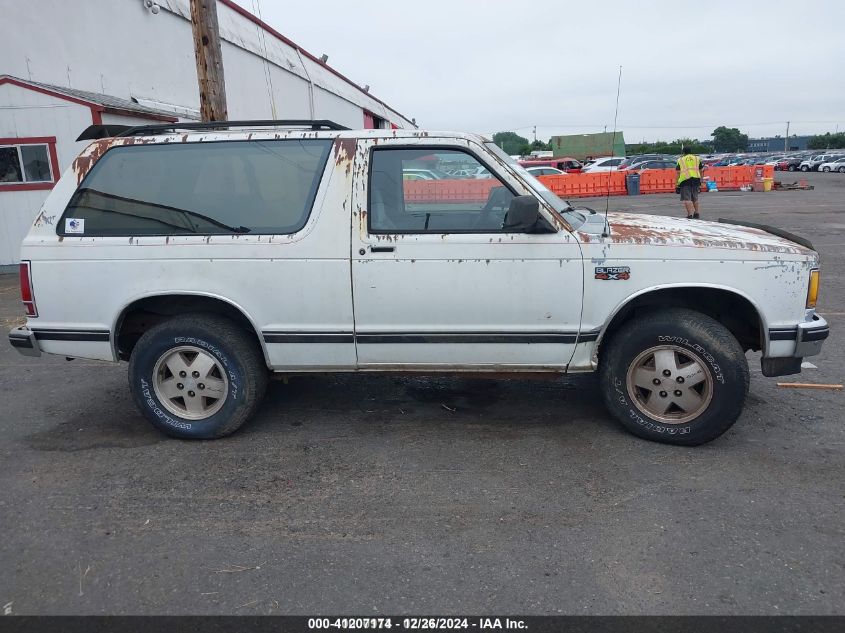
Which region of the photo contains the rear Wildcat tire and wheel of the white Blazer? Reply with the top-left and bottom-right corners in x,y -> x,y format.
129,314 -> 268,439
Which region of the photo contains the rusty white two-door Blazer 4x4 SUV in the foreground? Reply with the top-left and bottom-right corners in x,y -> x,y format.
10,121 -> 828,445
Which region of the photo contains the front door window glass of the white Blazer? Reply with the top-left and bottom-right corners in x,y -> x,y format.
368,147 -> 515,233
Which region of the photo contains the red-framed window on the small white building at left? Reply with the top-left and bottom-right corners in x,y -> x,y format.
0,136 -> 58,192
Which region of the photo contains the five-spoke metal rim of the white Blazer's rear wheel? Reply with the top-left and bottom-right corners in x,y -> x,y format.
153,345 -> 229,420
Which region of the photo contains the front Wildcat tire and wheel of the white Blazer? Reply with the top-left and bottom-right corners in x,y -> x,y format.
599,308 -> 750,446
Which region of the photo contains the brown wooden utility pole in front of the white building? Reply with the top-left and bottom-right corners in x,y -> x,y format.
191,0 -> 229,121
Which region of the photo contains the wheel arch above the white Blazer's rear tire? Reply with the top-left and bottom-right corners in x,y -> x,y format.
112,291 -> 270,367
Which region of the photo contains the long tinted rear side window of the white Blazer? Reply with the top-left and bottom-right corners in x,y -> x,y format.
58,139 -> 332,236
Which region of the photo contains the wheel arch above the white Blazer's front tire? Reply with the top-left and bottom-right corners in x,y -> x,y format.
593,284 -> 769,363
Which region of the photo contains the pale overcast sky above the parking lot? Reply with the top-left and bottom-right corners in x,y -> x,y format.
238,0 -> 845,143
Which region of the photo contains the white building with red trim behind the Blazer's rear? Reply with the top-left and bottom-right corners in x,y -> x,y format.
0,0 -> 414,266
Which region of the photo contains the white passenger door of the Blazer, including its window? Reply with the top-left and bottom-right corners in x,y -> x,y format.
352,138 -> 583,370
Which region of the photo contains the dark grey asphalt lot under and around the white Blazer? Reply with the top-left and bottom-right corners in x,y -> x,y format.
0,168 -> 845,615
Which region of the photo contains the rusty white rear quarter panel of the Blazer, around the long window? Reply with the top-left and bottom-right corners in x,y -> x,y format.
21,139 -> 355,366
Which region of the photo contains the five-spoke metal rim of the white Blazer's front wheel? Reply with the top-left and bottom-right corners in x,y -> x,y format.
626,345 -> 713,424
